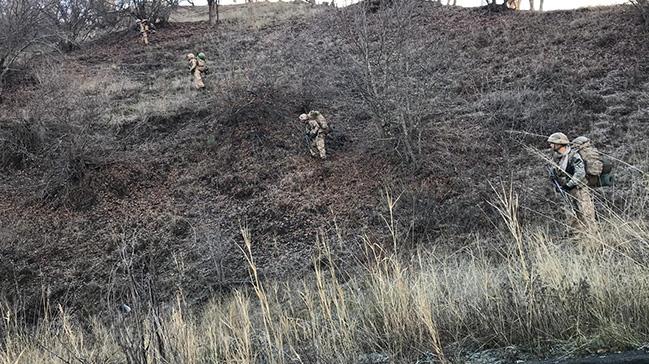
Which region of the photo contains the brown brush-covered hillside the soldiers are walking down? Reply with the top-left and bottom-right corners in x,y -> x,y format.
0,2 -> 649,311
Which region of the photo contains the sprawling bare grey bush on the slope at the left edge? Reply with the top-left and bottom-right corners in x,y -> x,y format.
0,66 -> 98,207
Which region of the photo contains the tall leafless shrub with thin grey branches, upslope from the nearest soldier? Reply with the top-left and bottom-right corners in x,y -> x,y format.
342,0 -> 434,166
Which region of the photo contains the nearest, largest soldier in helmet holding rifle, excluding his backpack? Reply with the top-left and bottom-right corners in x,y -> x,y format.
548,133 -> 596,229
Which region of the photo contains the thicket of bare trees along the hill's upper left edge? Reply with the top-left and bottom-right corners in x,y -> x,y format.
0,0 -> 178,92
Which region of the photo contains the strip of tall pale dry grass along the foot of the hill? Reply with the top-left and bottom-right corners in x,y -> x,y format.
0,189 -> 649,364
